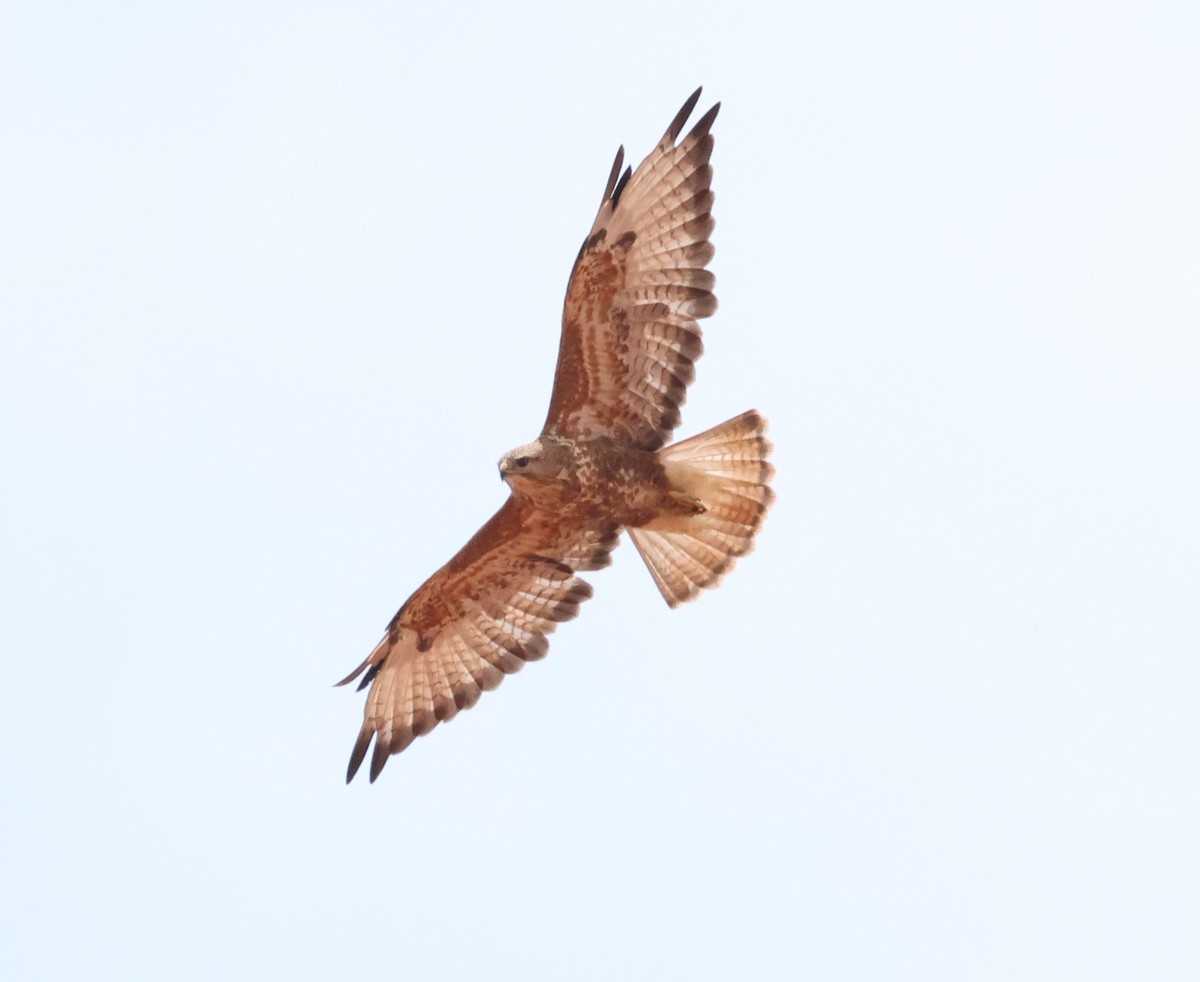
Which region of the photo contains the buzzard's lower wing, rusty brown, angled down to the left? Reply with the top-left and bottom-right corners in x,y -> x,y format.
337,497 -> 619,783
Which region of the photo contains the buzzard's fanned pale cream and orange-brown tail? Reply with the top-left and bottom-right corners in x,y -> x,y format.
629,409 -> 775,606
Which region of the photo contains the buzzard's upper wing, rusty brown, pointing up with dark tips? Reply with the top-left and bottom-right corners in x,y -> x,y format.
544,89 -> 720,450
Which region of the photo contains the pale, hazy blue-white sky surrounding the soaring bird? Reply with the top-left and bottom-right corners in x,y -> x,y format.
0,2 -> 1200,982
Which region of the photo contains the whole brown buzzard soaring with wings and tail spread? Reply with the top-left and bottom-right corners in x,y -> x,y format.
338,89 -> 774,782
